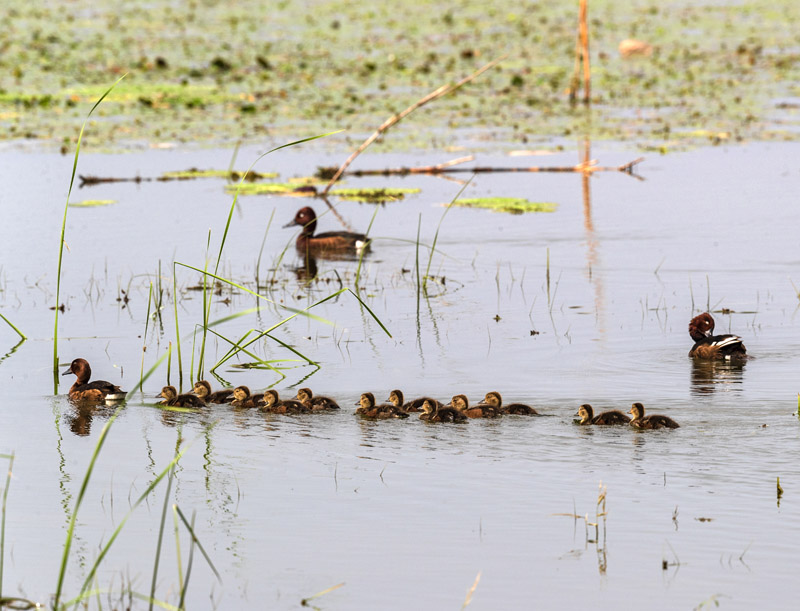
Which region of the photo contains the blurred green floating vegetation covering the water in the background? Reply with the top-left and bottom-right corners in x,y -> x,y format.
0,0 -> 800,152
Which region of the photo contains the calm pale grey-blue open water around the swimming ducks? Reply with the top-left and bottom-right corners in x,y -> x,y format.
0,142 -> 800,609
